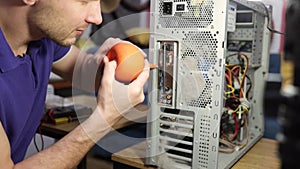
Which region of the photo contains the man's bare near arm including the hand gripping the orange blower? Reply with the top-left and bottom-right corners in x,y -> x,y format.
0,51 -> 150,169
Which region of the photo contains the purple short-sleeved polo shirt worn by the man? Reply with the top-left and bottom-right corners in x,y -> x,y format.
0,29 -> 70,163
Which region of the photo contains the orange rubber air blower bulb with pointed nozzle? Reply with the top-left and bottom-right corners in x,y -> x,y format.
107,42 -> 157,83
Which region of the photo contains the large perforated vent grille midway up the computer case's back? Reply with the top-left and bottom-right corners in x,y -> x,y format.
179,31 -> 218,108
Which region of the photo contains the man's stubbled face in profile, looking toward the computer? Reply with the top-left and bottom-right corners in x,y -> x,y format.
29,0 -> 102,46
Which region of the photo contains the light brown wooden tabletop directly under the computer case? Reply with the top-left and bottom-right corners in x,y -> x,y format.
112,138 -> 281,169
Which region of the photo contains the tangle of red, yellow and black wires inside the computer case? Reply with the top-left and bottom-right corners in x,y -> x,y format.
219,52 -> 251,153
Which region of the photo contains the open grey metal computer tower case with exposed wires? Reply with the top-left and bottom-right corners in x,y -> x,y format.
146,0 -> 271,169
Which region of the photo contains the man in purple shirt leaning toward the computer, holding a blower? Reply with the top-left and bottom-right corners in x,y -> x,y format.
0,0 -> 149,169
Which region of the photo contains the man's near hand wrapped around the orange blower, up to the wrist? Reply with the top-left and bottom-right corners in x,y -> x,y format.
98,57 -> 150,114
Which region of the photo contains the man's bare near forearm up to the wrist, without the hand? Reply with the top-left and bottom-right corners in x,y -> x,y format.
0,106 -> 119,169
